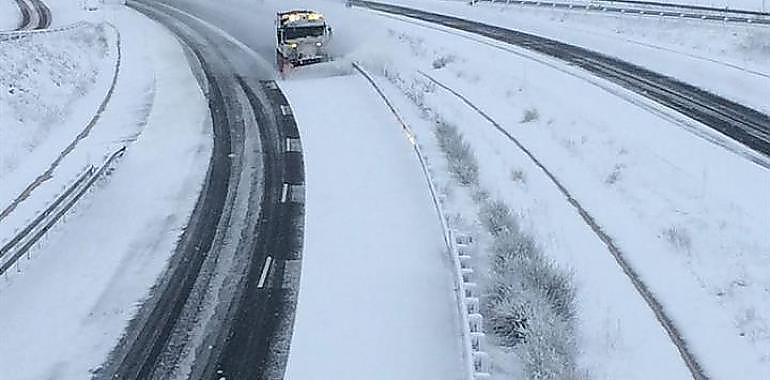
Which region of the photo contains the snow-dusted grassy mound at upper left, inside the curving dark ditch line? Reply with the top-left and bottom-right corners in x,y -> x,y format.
0,24 -> 111,182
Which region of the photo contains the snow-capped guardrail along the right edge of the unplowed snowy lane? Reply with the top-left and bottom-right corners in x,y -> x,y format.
353,62 -> 490,380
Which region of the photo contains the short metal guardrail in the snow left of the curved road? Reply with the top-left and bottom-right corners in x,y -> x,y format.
0,146 -> 126,275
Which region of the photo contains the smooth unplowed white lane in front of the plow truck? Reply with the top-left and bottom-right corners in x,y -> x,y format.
280,76 -> 463,380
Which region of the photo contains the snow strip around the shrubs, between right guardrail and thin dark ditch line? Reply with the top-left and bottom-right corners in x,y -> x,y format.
378,68 -> 689,379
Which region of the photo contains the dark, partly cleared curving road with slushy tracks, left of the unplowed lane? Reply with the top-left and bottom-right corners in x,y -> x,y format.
95,0 -> 304,379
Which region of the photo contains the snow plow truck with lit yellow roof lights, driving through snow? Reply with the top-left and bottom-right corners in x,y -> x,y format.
276,10 -> 332,73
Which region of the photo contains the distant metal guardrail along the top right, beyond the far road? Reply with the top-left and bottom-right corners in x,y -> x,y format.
470,0 -> 770,25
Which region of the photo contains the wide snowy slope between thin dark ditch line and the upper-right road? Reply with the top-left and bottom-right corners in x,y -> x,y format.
358,12 -> 770,378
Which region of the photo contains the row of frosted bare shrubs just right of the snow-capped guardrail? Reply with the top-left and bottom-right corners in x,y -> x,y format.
386,67 -> 580,380
